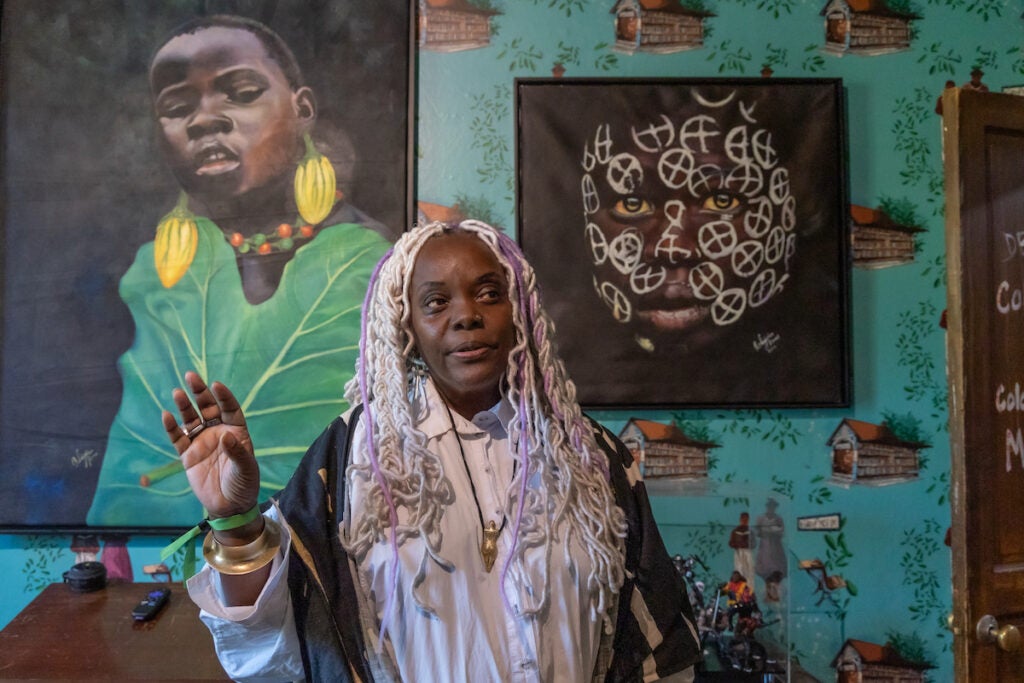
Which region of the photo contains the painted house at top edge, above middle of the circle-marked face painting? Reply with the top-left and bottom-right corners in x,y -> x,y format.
611,0 -> 715,54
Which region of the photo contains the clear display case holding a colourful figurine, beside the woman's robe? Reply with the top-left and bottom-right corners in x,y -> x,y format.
645,475 -> 827,683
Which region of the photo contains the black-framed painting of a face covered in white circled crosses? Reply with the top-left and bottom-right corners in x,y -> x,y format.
515,78 -> 851,409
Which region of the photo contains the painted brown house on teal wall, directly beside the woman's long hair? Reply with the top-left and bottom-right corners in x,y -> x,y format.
618,418 -> 719,479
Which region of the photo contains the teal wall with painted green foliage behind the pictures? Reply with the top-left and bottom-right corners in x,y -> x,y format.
0,0 -> 1024,681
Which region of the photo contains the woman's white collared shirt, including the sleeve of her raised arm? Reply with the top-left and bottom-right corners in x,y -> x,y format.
188,382 -> 601,683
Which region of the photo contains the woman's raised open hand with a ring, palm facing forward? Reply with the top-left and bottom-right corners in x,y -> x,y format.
163,372 -> 259,518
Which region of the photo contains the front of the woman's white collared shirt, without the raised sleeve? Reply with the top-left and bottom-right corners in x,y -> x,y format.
349,382 -> 601,682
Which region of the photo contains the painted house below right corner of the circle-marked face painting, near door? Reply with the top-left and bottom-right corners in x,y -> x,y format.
828,418 -> 929,486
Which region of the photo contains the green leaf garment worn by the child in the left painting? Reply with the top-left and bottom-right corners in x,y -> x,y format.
88,218 -> 390,527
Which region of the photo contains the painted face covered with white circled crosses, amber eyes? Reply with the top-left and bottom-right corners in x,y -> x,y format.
582,93 -> 797,347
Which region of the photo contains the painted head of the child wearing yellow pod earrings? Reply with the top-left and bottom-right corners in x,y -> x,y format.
150,27 -> 313,200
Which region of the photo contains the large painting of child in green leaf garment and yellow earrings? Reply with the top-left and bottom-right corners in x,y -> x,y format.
0,2 -> 410,527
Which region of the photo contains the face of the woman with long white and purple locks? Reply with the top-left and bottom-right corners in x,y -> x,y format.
409,232 -> 515,418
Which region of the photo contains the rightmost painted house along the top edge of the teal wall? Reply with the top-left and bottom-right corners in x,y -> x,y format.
821,0 -> 921,55
